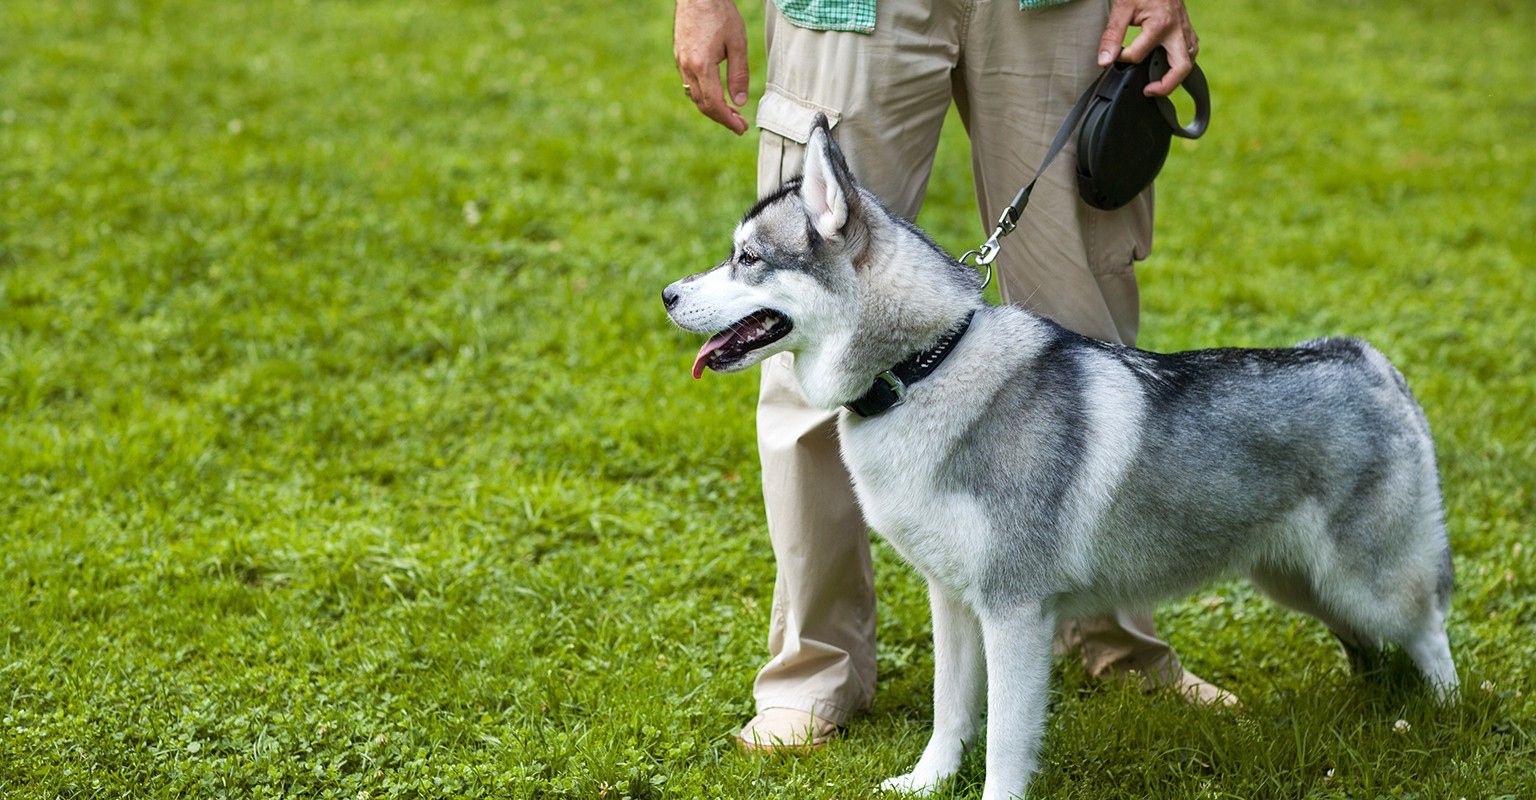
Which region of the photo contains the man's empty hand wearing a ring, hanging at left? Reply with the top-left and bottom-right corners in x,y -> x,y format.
673,0 -> 746,135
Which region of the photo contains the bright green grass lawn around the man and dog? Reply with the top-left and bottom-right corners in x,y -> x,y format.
0,0 -> 1536,798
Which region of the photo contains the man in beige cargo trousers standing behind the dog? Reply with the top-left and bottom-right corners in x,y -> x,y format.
674,0 -> 1235,749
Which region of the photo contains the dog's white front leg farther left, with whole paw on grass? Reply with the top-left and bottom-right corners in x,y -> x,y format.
880,580 -> 986,794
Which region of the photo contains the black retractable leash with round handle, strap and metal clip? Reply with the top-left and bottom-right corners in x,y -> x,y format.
960,48 -> 1210,289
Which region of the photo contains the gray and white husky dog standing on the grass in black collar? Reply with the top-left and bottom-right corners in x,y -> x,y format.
662,118 -> 1456,800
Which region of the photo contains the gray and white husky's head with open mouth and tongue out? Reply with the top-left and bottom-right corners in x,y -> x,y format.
662,115 -> 872,378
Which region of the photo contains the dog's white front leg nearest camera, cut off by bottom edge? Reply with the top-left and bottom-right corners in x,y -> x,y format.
982,602 -> 1055,800
